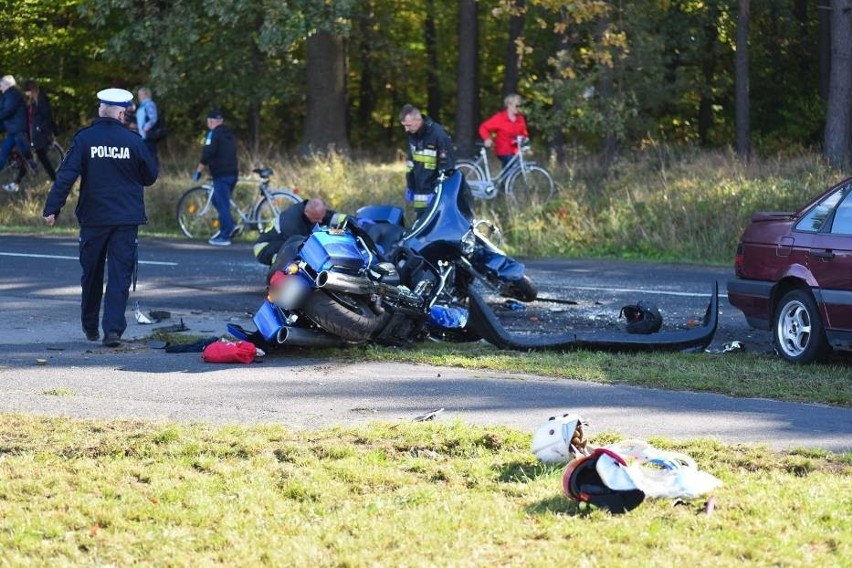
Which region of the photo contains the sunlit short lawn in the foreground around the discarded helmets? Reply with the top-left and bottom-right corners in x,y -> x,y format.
0,415 -> 852,566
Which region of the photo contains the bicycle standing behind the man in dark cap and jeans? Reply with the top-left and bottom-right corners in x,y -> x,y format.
177,168 -> 302,240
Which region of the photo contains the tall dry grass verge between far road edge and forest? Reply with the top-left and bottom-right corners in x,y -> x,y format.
0,145 -> 846,263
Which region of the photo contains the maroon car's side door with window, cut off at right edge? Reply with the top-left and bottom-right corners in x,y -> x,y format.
797,184 -> 852,331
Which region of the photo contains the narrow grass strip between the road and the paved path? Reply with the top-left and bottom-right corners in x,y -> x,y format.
273,343 -> 852,407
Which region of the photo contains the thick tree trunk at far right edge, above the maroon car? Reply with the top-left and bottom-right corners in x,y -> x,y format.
825,0 -> 852,168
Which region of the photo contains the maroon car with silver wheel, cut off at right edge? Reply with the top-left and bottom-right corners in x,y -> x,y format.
728,178 -> 852,363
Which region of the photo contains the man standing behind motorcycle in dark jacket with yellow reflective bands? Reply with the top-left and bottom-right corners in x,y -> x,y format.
399,104 -> 456,217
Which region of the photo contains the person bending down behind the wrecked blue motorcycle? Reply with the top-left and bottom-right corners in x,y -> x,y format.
254,197 -> 346,280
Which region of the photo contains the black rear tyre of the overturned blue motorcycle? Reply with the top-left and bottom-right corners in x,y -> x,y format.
302,290 -> 386,341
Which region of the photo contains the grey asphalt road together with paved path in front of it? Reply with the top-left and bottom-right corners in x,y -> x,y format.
0,235 -> 852,451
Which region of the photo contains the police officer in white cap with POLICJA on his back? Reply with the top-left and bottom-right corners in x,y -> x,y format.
42,89 -> 158,347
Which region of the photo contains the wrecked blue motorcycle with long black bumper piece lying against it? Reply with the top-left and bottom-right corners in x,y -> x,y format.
235,172 -> 718,350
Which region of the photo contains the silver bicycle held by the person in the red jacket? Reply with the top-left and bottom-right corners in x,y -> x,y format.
456,136 -> 556,206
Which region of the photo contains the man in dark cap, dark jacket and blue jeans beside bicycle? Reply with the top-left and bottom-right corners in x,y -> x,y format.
192,109 -> 240,246
